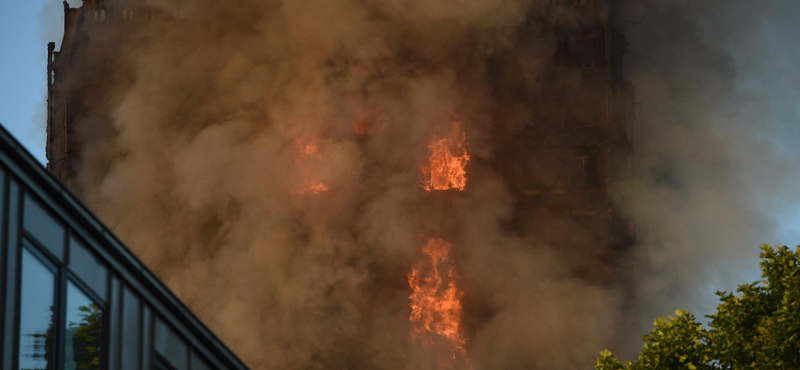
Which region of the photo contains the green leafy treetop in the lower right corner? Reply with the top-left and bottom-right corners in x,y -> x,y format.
595,245 -> 800,370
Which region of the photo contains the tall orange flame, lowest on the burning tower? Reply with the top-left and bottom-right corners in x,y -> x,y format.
408,238 -> 467,363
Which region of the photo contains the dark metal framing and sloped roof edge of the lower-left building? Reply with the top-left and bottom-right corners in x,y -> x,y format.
0,126 -> 247,370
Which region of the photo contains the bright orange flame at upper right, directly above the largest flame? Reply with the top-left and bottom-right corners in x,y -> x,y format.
422,117 -> 469,191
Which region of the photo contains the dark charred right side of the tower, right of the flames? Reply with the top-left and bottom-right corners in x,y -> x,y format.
504,1 -> 635,282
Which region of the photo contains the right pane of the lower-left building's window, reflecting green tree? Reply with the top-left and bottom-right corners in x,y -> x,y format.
65,281 -> 103,370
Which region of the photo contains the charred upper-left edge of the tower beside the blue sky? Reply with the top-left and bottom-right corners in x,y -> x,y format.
46,0 -> 156,187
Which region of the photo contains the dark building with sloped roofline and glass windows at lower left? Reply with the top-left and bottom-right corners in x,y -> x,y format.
0,127 -> 246,370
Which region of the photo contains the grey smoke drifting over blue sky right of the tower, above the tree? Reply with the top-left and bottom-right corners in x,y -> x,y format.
623,1 -> 800,352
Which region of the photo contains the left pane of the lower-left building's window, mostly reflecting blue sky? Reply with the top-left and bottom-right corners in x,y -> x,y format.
19,248 -> 55,370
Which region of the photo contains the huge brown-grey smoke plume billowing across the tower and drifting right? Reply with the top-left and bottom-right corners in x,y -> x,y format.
59,0 -> 800,369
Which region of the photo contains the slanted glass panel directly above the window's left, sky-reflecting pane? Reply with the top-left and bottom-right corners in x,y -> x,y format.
22,194 -> 65,261
